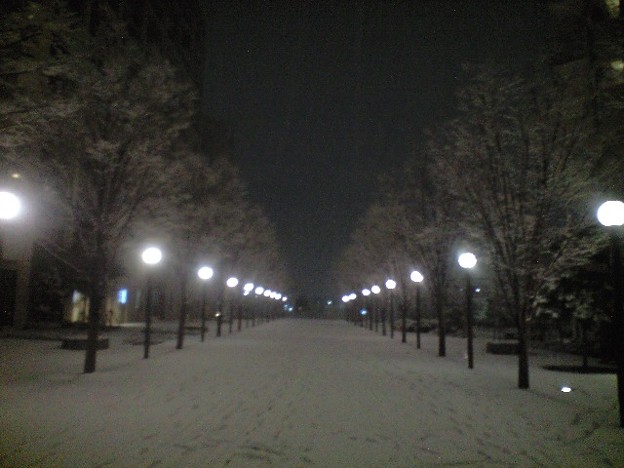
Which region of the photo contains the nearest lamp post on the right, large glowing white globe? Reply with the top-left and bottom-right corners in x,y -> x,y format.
596,200 -> 624,427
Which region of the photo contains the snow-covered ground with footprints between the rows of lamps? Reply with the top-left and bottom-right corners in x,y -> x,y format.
0,320 -> 624,467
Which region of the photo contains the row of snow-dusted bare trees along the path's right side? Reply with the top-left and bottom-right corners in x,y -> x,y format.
335,3 -> 624,388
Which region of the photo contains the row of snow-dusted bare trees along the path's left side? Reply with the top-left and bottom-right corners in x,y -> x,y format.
0,1 -> 288,372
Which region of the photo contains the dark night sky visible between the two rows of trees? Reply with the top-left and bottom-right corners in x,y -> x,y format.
204,0 -> 545,296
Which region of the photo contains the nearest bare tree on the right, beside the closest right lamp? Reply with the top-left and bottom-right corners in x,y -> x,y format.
437,66 -> 597,388
